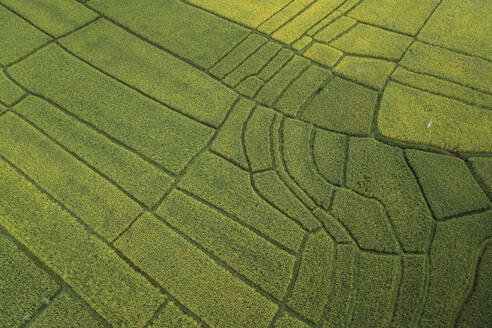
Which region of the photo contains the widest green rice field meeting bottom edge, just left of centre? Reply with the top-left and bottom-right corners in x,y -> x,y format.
115,213 -> 277,327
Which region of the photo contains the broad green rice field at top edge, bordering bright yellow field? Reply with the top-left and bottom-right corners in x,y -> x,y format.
89,0 -> 248,69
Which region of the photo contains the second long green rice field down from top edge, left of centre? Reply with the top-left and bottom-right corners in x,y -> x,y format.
60,20 -> 237,127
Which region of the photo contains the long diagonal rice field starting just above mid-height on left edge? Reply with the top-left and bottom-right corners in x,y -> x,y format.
0,113 -> 142,240
